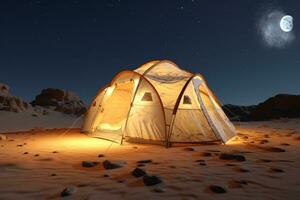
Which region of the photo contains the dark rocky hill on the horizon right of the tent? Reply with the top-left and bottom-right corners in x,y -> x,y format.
223,94 -> 300,121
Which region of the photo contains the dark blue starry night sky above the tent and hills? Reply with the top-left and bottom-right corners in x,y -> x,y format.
0,0 -> 300,105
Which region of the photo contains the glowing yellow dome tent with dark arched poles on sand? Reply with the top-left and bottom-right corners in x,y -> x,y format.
82,60 -> 236,147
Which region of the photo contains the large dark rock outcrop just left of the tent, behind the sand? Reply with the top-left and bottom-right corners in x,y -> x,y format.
31,88 -> 86,116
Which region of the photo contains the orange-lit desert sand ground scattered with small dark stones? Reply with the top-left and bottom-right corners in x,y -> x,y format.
0,119 -> 300,200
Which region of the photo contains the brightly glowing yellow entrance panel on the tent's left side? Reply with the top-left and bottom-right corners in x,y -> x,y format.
95,81 -> 134,140
